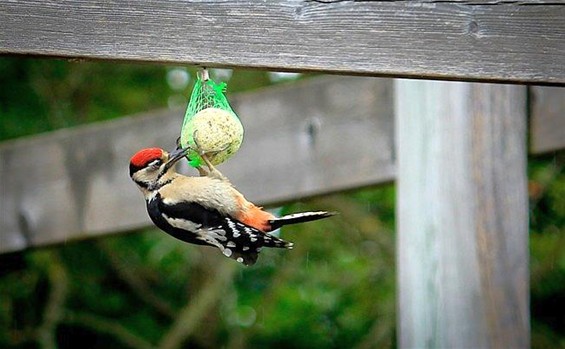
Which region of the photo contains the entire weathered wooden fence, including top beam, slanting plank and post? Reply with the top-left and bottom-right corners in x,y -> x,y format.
0,0 -> 565,348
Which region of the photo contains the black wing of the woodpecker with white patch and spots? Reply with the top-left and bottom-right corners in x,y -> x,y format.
147,193 -> 293,265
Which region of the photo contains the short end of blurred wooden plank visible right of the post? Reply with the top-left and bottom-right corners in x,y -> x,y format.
530,86 -> 565,154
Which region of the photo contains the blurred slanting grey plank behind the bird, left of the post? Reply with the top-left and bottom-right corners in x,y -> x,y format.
0,77 -> 394,252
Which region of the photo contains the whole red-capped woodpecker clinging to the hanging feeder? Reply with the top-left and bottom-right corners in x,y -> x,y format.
129,148 -> 335,265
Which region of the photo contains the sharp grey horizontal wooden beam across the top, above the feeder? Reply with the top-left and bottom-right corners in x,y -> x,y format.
0,0 -> 565,84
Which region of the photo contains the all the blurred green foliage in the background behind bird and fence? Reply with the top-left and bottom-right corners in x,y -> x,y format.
0,57 -> 565,348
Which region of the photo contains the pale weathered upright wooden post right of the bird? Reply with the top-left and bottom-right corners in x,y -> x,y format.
395,80 -> 530,348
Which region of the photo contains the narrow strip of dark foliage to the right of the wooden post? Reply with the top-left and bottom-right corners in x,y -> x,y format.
529,155 -> 565,348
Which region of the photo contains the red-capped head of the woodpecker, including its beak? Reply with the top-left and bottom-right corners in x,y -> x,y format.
129,148 -> 187,193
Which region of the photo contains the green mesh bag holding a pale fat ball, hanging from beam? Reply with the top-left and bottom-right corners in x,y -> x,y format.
180,71 -> 243,167
